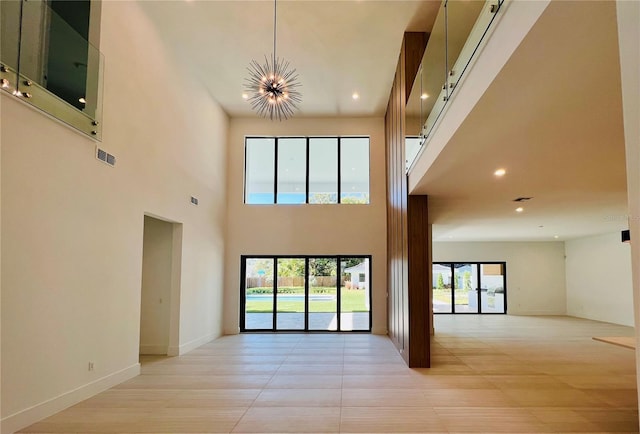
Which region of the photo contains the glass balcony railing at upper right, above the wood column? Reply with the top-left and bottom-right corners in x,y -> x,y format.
405,0 -> 506,172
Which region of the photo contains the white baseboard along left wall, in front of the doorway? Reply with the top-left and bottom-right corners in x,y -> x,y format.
0,363 -> 140,434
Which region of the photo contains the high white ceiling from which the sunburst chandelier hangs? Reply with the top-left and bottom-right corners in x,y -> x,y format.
140,0 -> 440,116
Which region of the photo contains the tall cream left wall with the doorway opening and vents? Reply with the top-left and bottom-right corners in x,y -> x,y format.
0,2 -> 228,433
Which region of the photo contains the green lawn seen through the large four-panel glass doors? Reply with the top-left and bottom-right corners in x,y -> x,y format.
246,288 -> 368,313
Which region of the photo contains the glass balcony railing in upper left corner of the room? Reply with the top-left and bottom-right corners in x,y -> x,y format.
0,0 -> 104,140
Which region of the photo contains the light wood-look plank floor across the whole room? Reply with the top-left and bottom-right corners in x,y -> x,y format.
23,315 -> 638,433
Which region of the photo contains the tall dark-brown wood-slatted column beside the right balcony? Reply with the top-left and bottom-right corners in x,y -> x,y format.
385,32 -> 431,368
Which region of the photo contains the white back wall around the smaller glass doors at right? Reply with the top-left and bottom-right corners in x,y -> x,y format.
433,242 -> 566,315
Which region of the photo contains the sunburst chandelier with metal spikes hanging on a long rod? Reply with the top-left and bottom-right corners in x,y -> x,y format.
245,0 -> 302,121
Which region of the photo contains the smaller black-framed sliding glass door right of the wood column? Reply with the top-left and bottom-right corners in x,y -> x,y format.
432,262 -> 507,313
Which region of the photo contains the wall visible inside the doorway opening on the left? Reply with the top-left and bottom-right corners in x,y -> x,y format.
140,216 -> 173,354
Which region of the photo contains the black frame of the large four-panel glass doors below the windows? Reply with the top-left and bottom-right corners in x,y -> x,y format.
239,254 -> 373,333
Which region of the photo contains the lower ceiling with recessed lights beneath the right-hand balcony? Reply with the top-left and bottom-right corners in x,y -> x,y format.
413,1 -> 628,241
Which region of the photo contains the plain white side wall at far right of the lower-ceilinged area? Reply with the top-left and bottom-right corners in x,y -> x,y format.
565,232 -> 633,327
